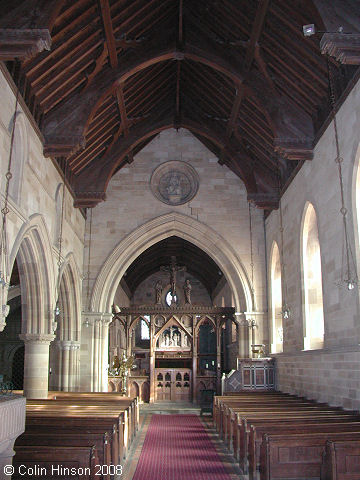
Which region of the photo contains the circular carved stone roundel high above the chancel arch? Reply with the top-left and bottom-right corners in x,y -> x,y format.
150,160 -> 199,205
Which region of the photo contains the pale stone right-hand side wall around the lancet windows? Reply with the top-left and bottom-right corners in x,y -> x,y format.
266,78 -> 360,409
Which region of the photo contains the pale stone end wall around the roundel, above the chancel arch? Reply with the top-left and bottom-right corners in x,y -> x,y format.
85,129 -> 265,311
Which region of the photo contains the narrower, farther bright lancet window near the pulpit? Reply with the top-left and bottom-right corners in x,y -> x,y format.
270,242 -> 283,353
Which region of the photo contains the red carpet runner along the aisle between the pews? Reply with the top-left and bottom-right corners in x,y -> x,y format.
133,415 -> 231,480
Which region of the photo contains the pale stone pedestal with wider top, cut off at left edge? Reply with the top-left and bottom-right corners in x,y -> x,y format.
0,395 -> 26,480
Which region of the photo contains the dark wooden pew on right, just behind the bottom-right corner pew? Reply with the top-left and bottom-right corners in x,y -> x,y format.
260,429 -> 360,480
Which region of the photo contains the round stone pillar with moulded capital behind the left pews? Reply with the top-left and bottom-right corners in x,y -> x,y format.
19,333 -> 55,398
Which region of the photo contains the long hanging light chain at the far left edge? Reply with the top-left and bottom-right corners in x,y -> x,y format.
0,84 -> 19,331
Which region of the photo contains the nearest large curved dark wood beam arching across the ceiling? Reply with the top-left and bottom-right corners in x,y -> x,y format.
43,41 -> 313,158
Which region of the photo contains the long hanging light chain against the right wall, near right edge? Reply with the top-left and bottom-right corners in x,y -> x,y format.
327,56 -> 359,291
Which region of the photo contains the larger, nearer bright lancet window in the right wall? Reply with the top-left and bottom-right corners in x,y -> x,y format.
301,203 -> 324,350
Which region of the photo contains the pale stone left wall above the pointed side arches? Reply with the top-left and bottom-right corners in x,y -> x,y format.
0,66 -> 85,318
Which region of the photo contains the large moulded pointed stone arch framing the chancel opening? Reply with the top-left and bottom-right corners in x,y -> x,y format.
91,212 -> 254,312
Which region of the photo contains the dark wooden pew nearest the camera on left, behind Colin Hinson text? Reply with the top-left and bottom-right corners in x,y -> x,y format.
12,445 -> 99,480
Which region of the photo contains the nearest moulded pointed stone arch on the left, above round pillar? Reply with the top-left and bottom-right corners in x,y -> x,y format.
9,214 -> 55,334
